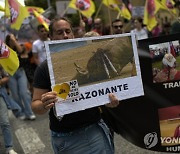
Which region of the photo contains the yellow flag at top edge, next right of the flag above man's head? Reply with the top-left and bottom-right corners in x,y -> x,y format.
102,0 -> 121,13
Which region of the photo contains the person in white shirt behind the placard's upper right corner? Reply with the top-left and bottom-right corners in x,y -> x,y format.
131,17 -> 148,40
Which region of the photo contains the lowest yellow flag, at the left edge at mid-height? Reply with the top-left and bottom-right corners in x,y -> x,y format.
0,40 -> 19,75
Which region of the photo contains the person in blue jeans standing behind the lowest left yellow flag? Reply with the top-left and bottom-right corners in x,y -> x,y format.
5,34 -> 36,120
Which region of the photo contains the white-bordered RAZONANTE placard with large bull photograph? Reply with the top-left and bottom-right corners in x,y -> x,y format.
45,33 -> 144,116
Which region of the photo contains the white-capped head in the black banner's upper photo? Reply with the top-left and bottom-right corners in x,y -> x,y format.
162,53 -> 176,68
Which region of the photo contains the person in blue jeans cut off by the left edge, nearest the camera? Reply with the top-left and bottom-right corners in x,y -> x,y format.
0,67 -> 17,154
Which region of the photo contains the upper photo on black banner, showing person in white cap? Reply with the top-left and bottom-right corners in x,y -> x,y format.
149,40 -> 180,83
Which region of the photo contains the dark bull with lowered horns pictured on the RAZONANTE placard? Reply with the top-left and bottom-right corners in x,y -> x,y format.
73,37 -> 133,85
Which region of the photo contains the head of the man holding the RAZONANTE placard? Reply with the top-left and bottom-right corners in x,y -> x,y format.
49,17 -> 74,40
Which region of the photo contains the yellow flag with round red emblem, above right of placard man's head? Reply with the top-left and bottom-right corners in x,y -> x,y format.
68,0 -> 95,18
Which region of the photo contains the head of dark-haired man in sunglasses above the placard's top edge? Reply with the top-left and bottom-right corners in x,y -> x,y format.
112,19 -> 124,34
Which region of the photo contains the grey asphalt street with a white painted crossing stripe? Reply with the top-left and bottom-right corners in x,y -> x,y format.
0,112 -> 173,154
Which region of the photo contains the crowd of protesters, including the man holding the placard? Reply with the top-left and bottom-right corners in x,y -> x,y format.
0,13 -> 180,154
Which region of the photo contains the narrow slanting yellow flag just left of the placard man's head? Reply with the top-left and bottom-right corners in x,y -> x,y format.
33,10 -> 50,31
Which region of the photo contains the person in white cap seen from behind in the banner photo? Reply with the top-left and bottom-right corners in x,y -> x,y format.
154,53 -> 180,82
